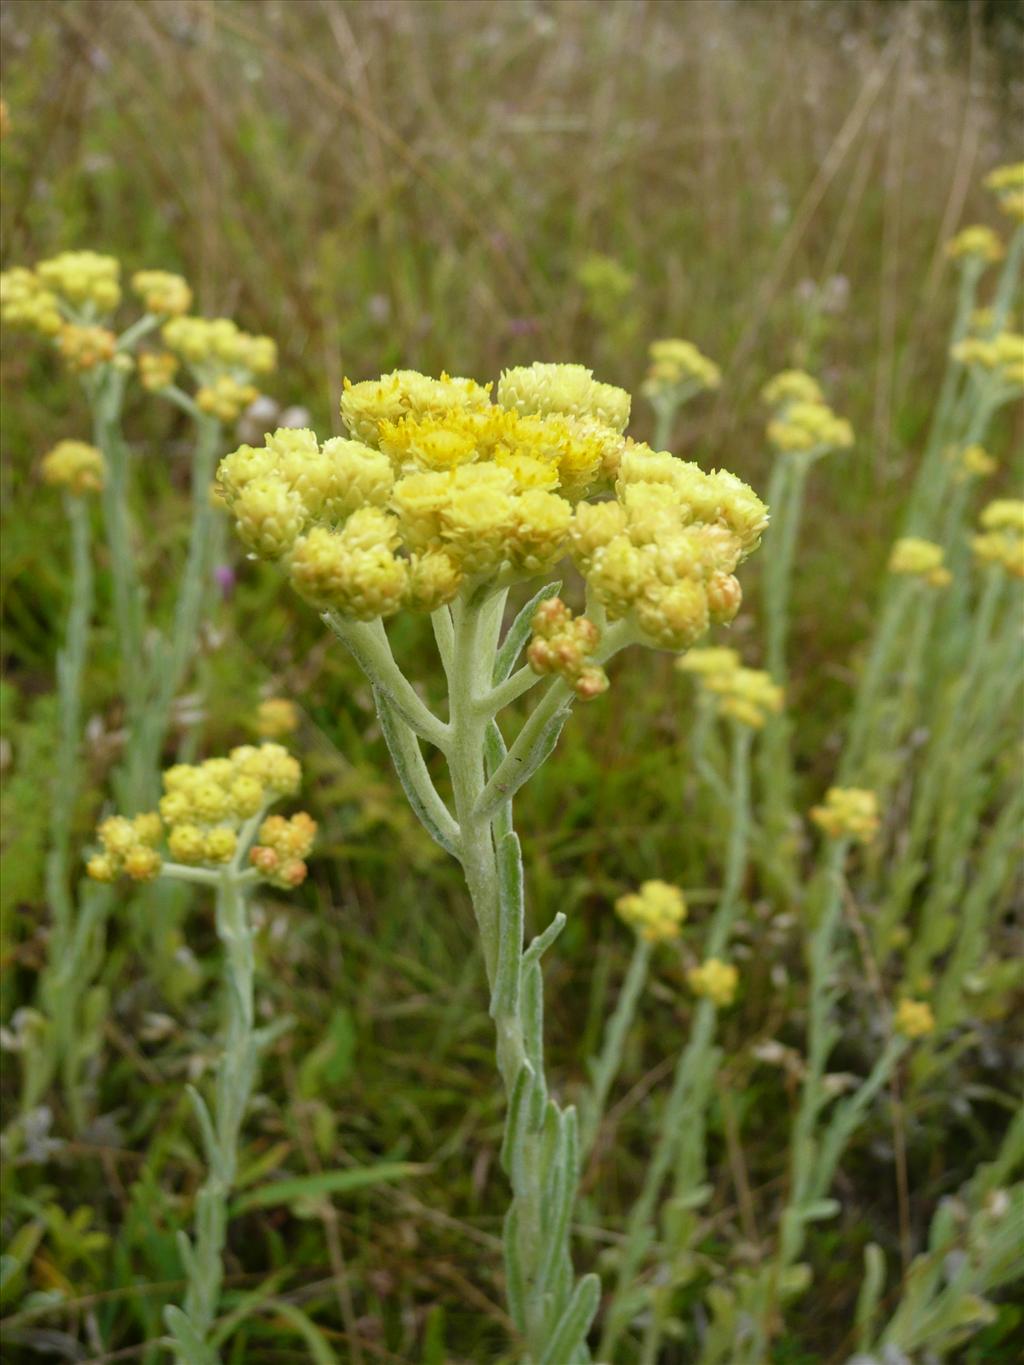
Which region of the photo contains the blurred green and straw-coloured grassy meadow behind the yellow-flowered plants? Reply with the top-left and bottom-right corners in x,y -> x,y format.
0,0 -> 1024,1365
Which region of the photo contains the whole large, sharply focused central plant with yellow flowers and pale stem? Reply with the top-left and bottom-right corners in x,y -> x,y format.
217,364 -> 767,1365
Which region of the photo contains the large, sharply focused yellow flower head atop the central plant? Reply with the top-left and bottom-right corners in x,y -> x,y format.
218,364 -> 767,648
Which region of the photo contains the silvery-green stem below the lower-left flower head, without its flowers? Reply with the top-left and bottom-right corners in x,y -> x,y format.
165,868 -> 258,1365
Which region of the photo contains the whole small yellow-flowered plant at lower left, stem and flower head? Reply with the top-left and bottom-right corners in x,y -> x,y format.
87,744 -> 317,1365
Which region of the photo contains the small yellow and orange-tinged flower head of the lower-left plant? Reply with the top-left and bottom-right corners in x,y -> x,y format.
87,744 -> 315,886
